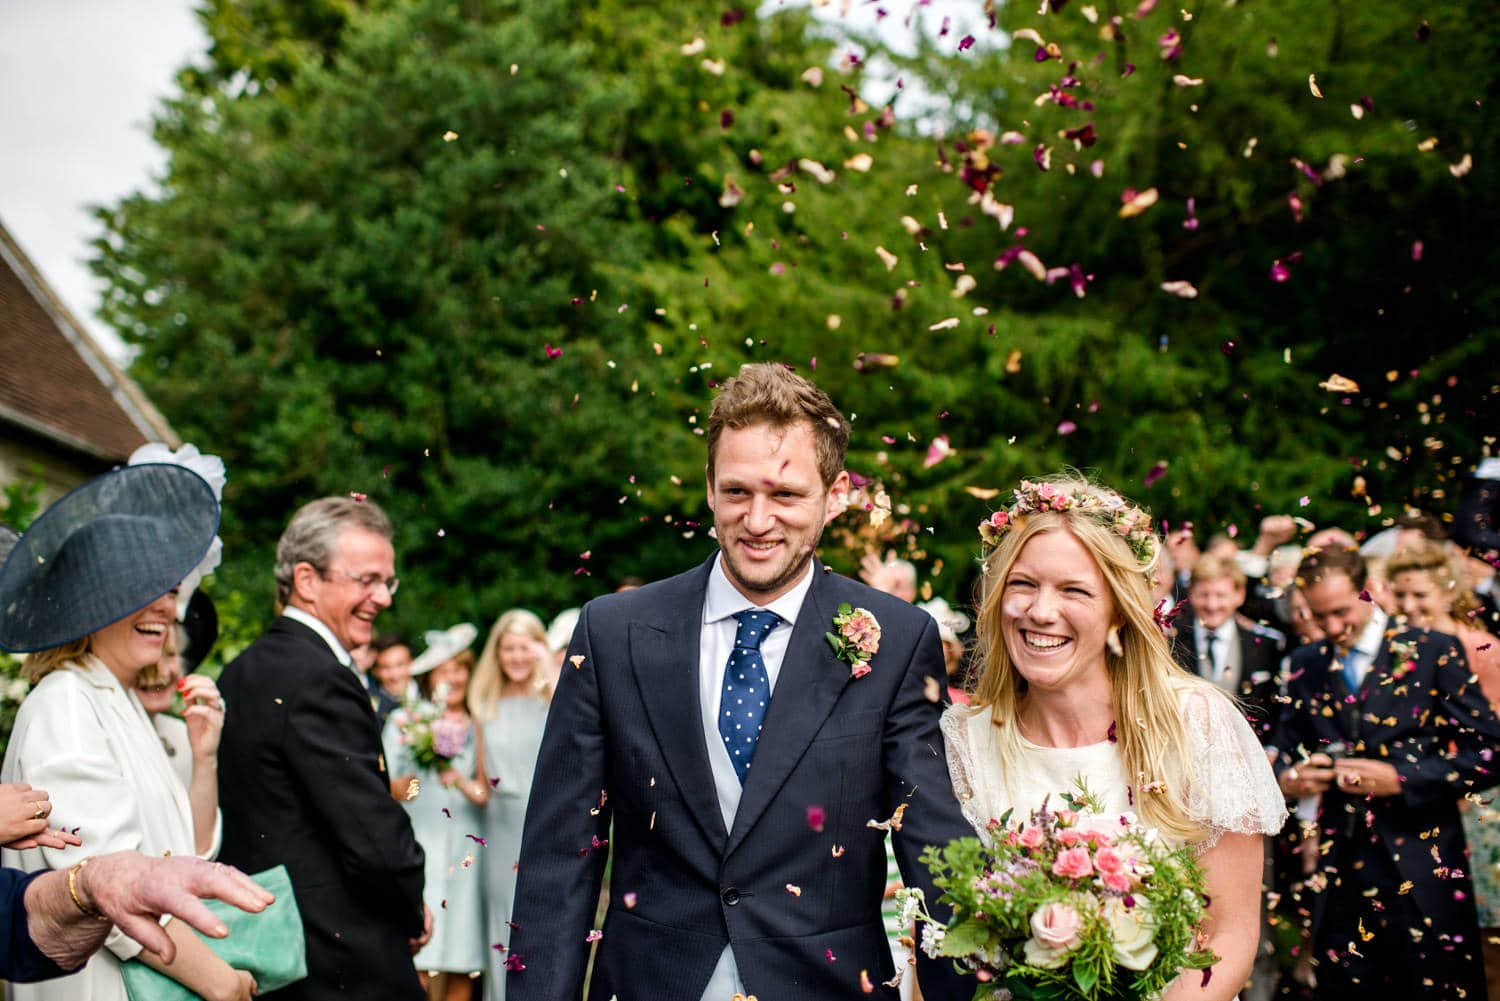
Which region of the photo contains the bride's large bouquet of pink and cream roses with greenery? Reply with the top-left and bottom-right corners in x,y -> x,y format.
897,786 -> 1218,1001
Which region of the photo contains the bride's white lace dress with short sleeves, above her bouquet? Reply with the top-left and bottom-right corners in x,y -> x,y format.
942,686 -> 1287,851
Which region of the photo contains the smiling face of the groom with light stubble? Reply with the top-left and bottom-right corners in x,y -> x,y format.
708,423 -> 849,605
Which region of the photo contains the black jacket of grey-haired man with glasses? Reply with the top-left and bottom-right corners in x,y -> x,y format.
219,618 -> 425,1001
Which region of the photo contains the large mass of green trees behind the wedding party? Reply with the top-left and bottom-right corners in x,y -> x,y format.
96,0 -> 1500,627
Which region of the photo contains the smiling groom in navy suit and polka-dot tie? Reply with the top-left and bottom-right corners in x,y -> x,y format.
507,365 -> 974,1001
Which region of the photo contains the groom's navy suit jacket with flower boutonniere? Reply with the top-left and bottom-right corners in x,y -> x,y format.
507,560 -> 975,1001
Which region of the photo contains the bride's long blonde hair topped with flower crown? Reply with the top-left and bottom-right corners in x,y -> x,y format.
974,476 -> 1208,843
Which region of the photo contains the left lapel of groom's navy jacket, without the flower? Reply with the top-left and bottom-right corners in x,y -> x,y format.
629,560 -> 728,851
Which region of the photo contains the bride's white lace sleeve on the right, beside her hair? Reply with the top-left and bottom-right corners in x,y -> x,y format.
1184,686 -> 1287,851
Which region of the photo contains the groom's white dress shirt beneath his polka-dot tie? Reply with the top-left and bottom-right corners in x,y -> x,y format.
698,554 -> 813,1001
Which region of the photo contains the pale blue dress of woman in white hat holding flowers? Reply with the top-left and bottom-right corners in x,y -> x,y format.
384,713 -> 488,974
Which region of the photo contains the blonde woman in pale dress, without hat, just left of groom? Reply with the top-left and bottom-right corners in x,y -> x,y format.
470,608 -> 552,1001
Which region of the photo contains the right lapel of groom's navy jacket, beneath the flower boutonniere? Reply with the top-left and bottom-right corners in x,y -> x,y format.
725,560 -> 849,857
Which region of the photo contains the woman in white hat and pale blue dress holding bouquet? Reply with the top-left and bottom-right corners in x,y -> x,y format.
384,623 -> 489,1001
